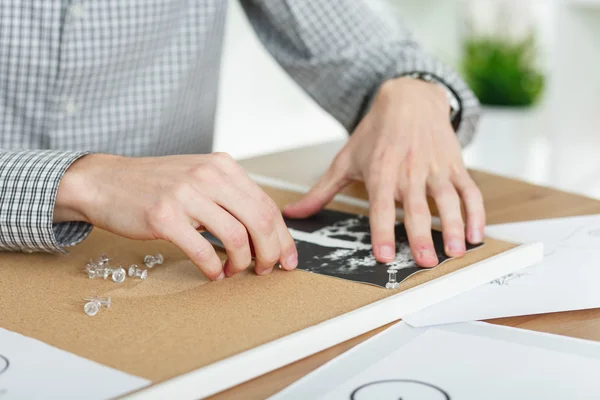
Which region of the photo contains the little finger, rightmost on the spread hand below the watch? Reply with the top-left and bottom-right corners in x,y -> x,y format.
454,170 -> 485,244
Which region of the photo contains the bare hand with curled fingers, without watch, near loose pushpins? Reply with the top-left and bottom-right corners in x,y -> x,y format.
54,153 -> 298,280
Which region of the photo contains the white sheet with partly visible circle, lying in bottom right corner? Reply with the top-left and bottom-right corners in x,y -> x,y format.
271,322 -> 600,400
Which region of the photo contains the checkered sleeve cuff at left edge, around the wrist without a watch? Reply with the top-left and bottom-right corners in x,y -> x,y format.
0,150 -> 92,253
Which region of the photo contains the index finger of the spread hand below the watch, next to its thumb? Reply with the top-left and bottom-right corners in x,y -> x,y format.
367,173 -> 396,263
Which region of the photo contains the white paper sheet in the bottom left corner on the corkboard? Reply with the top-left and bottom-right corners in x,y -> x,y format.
0,328 -> 151,400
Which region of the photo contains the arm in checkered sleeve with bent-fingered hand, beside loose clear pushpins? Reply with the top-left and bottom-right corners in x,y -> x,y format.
0,150 -> 298,280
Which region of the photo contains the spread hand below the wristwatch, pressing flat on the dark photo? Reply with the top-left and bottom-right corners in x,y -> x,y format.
284,78 -> 485,267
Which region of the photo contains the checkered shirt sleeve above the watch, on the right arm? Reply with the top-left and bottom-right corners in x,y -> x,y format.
242,0 -> 480,146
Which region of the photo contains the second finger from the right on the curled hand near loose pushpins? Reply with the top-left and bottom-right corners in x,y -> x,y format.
211,183 -> 281,275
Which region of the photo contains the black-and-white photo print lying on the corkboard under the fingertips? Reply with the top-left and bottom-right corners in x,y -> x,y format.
203,210 -> 480,287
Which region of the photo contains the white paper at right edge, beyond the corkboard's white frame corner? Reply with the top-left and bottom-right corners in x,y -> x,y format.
404,215 -> 600,326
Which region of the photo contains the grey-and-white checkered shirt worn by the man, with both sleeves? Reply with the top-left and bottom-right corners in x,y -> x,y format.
0,0 -> 479,252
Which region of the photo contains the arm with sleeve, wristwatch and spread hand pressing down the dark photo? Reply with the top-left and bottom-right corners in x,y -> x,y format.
242,0 -> 485,267
